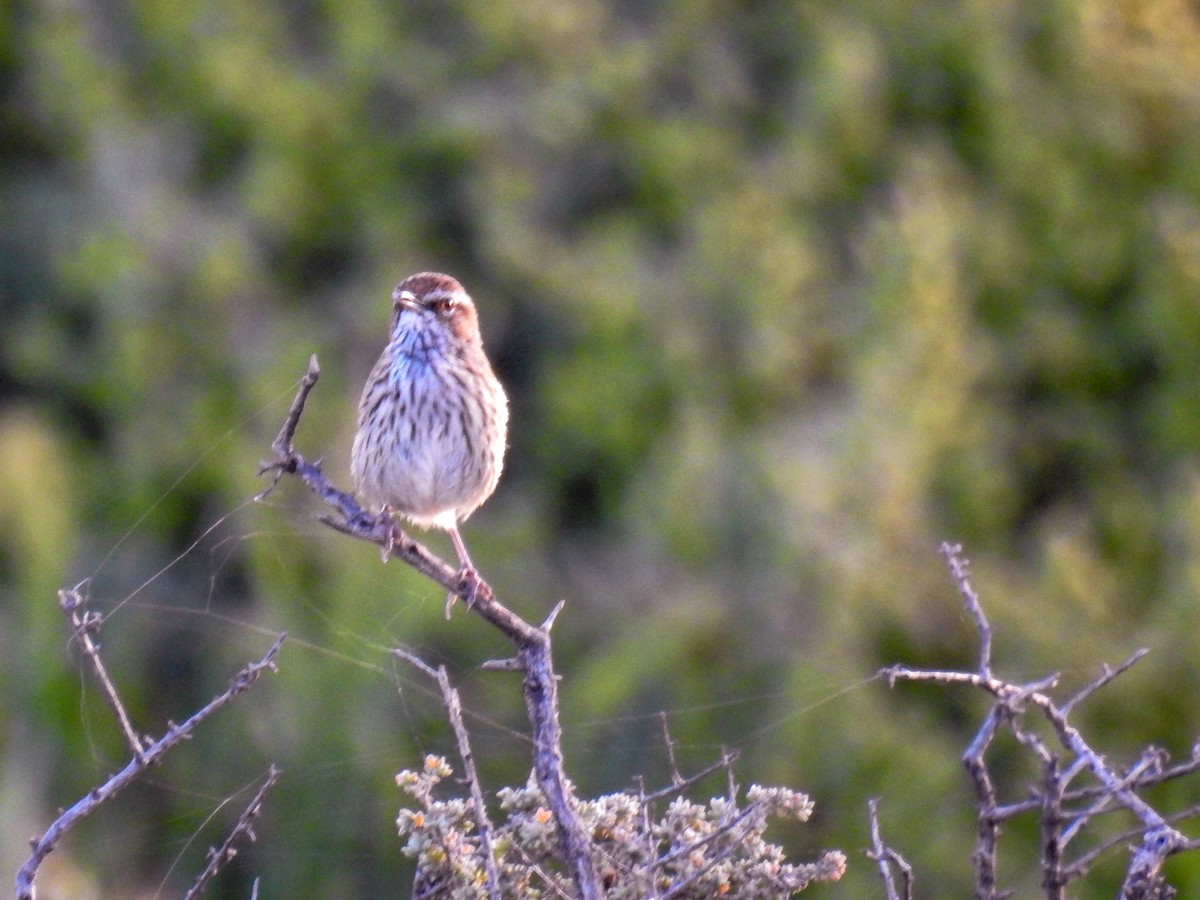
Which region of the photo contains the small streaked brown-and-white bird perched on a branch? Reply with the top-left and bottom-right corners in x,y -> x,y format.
350,272 -> 509,618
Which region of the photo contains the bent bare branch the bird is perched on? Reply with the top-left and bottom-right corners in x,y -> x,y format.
259,356 -> 604,900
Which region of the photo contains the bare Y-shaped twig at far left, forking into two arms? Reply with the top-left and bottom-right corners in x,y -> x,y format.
17,589 -> 287,900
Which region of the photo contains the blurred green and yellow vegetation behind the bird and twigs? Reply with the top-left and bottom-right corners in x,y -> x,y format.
0,0 -> 1200,898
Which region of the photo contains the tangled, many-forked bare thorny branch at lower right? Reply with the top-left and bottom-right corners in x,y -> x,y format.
872,544 -> 1200,900
